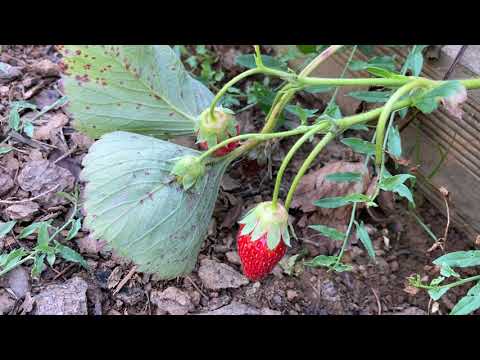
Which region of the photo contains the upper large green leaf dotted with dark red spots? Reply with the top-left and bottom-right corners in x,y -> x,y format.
62,45 -> 213,138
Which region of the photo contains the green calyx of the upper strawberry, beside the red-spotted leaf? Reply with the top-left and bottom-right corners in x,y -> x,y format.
196,108 -> 240,152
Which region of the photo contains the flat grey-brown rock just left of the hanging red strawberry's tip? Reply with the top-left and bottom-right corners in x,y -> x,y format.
198,259 -> 249,290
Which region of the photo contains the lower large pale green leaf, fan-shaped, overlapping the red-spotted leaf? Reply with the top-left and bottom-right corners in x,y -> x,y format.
82,132 -> 228,279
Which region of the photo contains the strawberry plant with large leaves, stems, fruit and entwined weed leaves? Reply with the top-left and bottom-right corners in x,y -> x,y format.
59,45 -> 480,296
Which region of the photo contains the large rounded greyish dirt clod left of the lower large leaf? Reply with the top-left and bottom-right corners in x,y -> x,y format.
18,160 -> 75,207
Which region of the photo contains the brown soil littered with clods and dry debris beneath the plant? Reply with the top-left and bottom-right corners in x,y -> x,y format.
0,45 -> 474,315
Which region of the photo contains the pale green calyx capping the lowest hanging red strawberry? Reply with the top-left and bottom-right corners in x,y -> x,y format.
239,201 -> 291,250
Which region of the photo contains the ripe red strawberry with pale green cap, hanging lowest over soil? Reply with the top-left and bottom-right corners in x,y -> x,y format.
237,202 -> 290,281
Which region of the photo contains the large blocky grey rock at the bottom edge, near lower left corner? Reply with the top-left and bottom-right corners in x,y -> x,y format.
34,277 -> 88,315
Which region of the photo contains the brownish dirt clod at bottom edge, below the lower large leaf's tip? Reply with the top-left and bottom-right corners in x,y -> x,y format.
150,287 -> 195,315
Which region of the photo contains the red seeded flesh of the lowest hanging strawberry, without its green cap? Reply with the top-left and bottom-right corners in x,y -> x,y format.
237,224 -> 287,281
